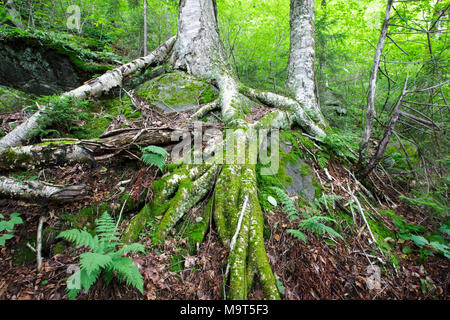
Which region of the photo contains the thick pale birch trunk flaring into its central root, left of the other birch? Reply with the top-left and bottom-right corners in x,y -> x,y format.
171,0 -> 245,124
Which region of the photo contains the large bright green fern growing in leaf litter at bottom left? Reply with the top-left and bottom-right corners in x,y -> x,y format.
58,211 -> 145,300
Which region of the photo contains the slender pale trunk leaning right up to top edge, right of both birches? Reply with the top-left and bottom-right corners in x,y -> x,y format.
359,0 -> 394,163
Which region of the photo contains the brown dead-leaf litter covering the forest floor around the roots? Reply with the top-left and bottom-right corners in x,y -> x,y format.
0,154 -> 449,300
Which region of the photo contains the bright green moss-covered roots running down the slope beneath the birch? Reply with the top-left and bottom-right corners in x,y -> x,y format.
122,160 -> 280,299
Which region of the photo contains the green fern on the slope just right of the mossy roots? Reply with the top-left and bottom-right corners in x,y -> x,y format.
273,187 -> 343,243
